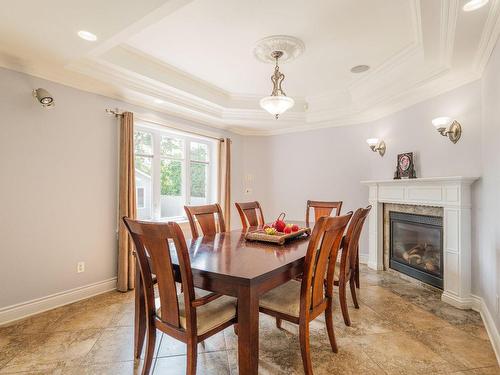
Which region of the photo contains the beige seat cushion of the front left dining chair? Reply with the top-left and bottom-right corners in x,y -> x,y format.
156,288 -> 237,336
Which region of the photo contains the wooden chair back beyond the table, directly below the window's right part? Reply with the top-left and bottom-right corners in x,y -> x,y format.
184,203 -> 226,238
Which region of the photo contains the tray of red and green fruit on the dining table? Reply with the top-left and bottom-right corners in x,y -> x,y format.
245,212 -> 311,245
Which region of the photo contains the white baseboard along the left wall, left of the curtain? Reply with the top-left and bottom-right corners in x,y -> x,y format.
0,277 -> 116,326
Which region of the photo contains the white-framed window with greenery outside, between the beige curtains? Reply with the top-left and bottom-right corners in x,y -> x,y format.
134,123 -> 217,220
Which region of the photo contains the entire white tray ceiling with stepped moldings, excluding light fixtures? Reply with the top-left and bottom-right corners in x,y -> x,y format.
0,0 -> 500,135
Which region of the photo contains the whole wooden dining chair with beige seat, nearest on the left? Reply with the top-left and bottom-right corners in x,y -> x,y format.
123,217 -> 237,375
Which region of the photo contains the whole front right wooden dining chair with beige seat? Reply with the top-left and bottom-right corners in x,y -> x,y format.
259,212 -> 352,375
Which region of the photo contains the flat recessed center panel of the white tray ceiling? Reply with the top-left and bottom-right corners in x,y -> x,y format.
127,0 -> 415,97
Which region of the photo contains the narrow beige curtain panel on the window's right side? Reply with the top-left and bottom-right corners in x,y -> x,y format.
219,138 -> 231,231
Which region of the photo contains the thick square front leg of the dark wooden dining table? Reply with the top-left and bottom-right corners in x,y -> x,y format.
238,286 -> 259,375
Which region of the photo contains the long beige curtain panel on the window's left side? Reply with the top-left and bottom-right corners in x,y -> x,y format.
117,112 -> 136,292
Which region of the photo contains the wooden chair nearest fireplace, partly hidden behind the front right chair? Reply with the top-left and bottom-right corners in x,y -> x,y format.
334,206 -> 372,326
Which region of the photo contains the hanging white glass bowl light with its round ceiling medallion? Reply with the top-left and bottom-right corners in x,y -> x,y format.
254,35 -> 305,120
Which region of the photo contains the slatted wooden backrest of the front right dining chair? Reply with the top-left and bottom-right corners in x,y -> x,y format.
301,212 -> 352,309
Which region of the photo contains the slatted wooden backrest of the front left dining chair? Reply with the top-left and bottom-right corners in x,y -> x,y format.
123,217 -> 195,328
